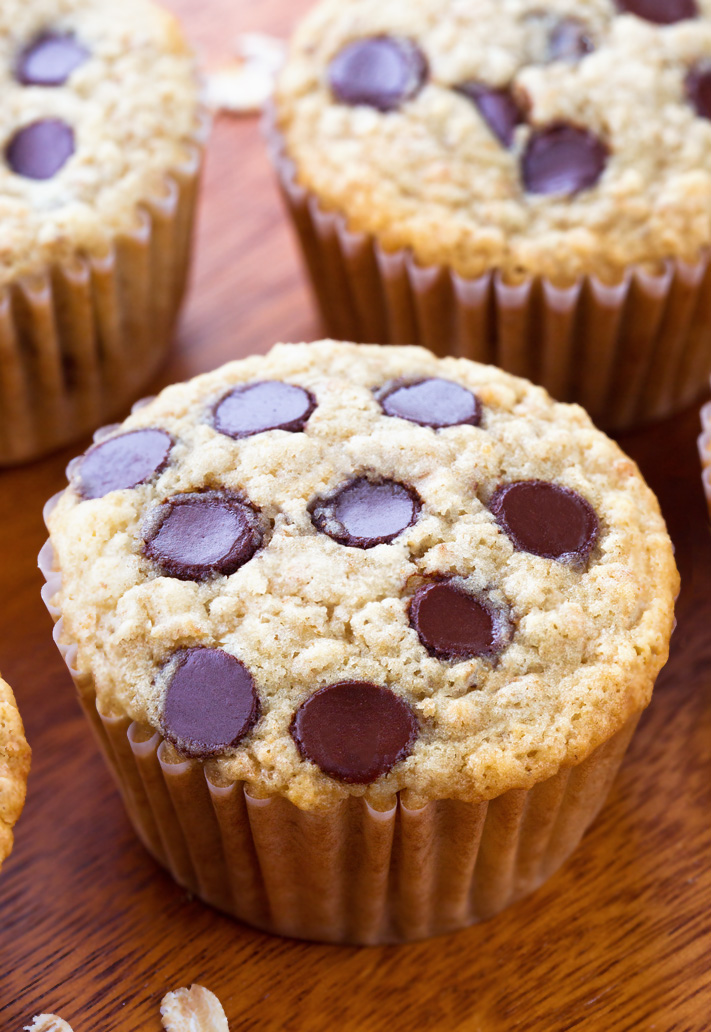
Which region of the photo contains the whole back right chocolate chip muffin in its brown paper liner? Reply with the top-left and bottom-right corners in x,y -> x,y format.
268,0 -> 711,428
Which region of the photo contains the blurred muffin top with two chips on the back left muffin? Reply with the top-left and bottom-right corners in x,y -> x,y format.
0,0 -> 199,287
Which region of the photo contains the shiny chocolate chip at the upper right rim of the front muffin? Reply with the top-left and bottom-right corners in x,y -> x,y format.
379,378 -> 481,429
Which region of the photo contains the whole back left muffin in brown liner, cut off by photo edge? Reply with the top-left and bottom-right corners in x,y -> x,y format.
0,0 -> 205,465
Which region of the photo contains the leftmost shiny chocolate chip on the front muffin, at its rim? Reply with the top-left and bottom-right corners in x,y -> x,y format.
75,429 -> 172,498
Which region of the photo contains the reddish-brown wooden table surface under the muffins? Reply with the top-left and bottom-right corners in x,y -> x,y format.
0,0 -> 711,1032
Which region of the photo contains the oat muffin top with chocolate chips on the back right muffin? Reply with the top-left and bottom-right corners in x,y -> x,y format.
277,0 -> 711,284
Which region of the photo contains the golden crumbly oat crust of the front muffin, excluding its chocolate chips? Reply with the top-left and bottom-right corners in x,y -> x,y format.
49,341 -> 678,808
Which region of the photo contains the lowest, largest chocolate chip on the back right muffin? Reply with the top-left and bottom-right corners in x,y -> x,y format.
522,125 -> 608,194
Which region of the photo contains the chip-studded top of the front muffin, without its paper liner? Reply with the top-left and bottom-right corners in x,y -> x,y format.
49,341 -> 677,807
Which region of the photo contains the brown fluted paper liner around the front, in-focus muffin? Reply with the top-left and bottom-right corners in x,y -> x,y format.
39,528 -> 639,945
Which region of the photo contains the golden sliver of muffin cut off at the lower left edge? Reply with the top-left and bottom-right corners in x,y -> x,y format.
0,677 -> 30,867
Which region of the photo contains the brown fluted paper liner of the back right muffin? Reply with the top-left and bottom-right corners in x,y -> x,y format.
264,110 -> 711,429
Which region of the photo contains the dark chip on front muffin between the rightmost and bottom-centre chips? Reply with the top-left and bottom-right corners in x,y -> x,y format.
410,581 -> 504,659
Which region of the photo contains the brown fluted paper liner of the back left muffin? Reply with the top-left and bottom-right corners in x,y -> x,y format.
0,115 -> 208,465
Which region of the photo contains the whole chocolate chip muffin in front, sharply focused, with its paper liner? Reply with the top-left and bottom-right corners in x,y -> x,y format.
40,341 -> 677,943
